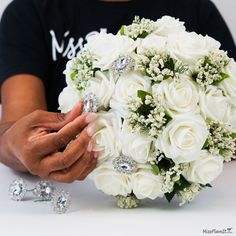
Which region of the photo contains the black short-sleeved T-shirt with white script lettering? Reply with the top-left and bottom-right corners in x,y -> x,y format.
0,0 -> 236,111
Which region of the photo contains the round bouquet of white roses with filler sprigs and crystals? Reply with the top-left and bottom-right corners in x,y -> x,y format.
59,16 -> 236,208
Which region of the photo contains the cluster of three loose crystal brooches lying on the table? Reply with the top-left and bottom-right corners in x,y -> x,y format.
9,178 -> 71,214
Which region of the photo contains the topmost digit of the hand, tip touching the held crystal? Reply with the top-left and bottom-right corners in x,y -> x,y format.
30,102 -> 83,130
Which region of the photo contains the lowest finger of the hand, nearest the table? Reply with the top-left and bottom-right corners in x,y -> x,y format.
48,151 -> 97,183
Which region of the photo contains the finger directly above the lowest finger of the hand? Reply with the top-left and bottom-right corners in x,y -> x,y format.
40,126 -> 92,174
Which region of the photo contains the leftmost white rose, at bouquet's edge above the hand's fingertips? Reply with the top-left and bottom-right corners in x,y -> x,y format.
58,86 -> 82,113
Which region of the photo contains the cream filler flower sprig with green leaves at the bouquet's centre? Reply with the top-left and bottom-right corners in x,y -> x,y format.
127,90 -> 171,138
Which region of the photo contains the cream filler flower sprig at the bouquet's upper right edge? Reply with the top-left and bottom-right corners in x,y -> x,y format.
192,51 -> 230,88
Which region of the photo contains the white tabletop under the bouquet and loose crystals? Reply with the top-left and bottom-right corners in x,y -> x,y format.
0,161 -> 236,236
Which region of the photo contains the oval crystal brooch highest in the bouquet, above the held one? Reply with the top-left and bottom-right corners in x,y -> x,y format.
112,56 -> 134,74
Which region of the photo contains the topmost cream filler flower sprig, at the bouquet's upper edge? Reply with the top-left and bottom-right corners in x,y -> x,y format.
120,16 -> 156,39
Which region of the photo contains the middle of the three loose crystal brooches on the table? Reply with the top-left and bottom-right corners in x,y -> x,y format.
34,180 -> 54,200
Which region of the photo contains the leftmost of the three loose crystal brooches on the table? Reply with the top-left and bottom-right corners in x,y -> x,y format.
9,179 -> 27,201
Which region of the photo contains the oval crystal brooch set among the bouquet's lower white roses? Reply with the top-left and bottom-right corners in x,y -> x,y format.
113,156 -> 137,175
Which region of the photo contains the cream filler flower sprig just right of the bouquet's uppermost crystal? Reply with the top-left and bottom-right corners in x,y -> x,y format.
134,50 -> 189,82
